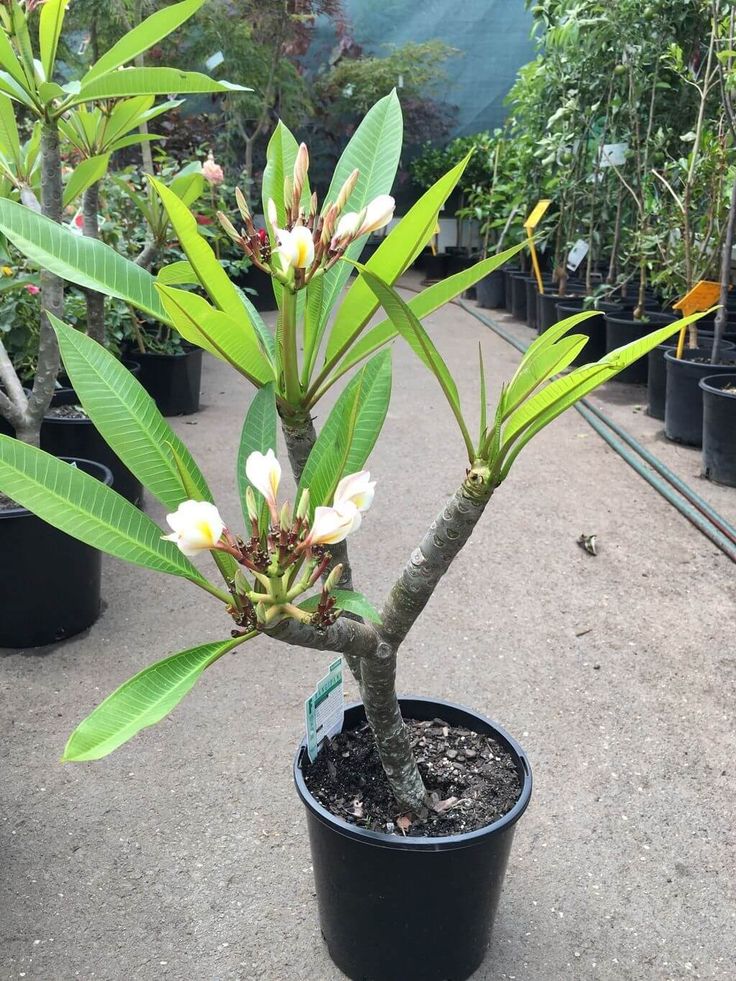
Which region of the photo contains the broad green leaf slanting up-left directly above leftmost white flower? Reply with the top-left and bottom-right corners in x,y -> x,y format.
49,314 -> 212,510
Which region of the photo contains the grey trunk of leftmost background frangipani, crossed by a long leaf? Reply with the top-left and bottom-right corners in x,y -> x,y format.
24,120 -> 64,445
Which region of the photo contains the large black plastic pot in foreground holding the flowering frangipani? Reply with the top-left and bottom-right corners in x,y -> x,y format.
294,698 -> 532,981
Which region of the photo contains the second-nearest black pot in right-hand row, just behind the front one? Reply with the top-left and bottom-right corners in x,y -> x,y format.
664,347 -> 736,446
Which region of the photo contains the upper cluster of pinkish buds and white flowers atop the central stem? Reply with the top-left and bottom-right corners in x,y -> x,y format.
218,143 -> 395,290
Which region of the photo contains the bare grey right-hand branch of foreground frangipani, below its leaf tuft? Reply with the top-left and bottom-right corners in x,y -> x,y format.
379,481 -> 492,650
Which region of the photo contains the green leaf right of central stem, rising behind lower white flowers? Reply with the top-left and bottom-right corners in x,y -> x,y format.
297,351 -> 391,514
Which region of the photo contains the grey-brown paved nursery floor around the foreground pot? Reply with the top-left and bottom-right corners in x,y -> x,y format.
0,276 -> 736,981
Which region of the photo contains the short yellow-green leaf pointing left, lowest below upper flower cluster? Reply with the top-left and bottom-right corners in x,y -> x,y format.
158,286 -> 274,387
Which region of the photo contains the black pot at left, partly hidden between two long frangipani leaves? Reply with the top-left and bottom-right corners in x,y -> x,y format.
41,388 -> 143,506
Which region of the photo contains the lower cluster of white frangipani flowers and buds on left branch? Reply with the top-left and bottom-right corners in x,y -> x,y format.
163,450 -> 375,634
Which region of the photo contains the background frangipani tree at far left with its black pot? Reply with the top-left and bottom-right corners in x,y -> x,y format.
0,0 -> 244,646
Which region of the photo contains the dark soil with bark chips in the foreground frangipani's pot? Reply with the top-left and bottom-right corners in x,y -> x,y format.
303,719 -> 521,838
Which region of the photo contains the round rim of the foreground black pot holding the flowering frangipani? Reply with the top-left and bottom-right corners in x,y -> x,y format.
293,695 -> 532,852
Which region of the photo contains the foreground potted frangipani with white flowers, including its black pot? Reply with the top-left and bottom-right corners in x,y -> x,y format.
0,94 -> 704,981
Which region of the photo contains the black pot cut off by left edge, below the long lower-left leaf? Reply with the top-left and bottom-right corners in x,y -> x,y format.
0,460 -> 112,647
